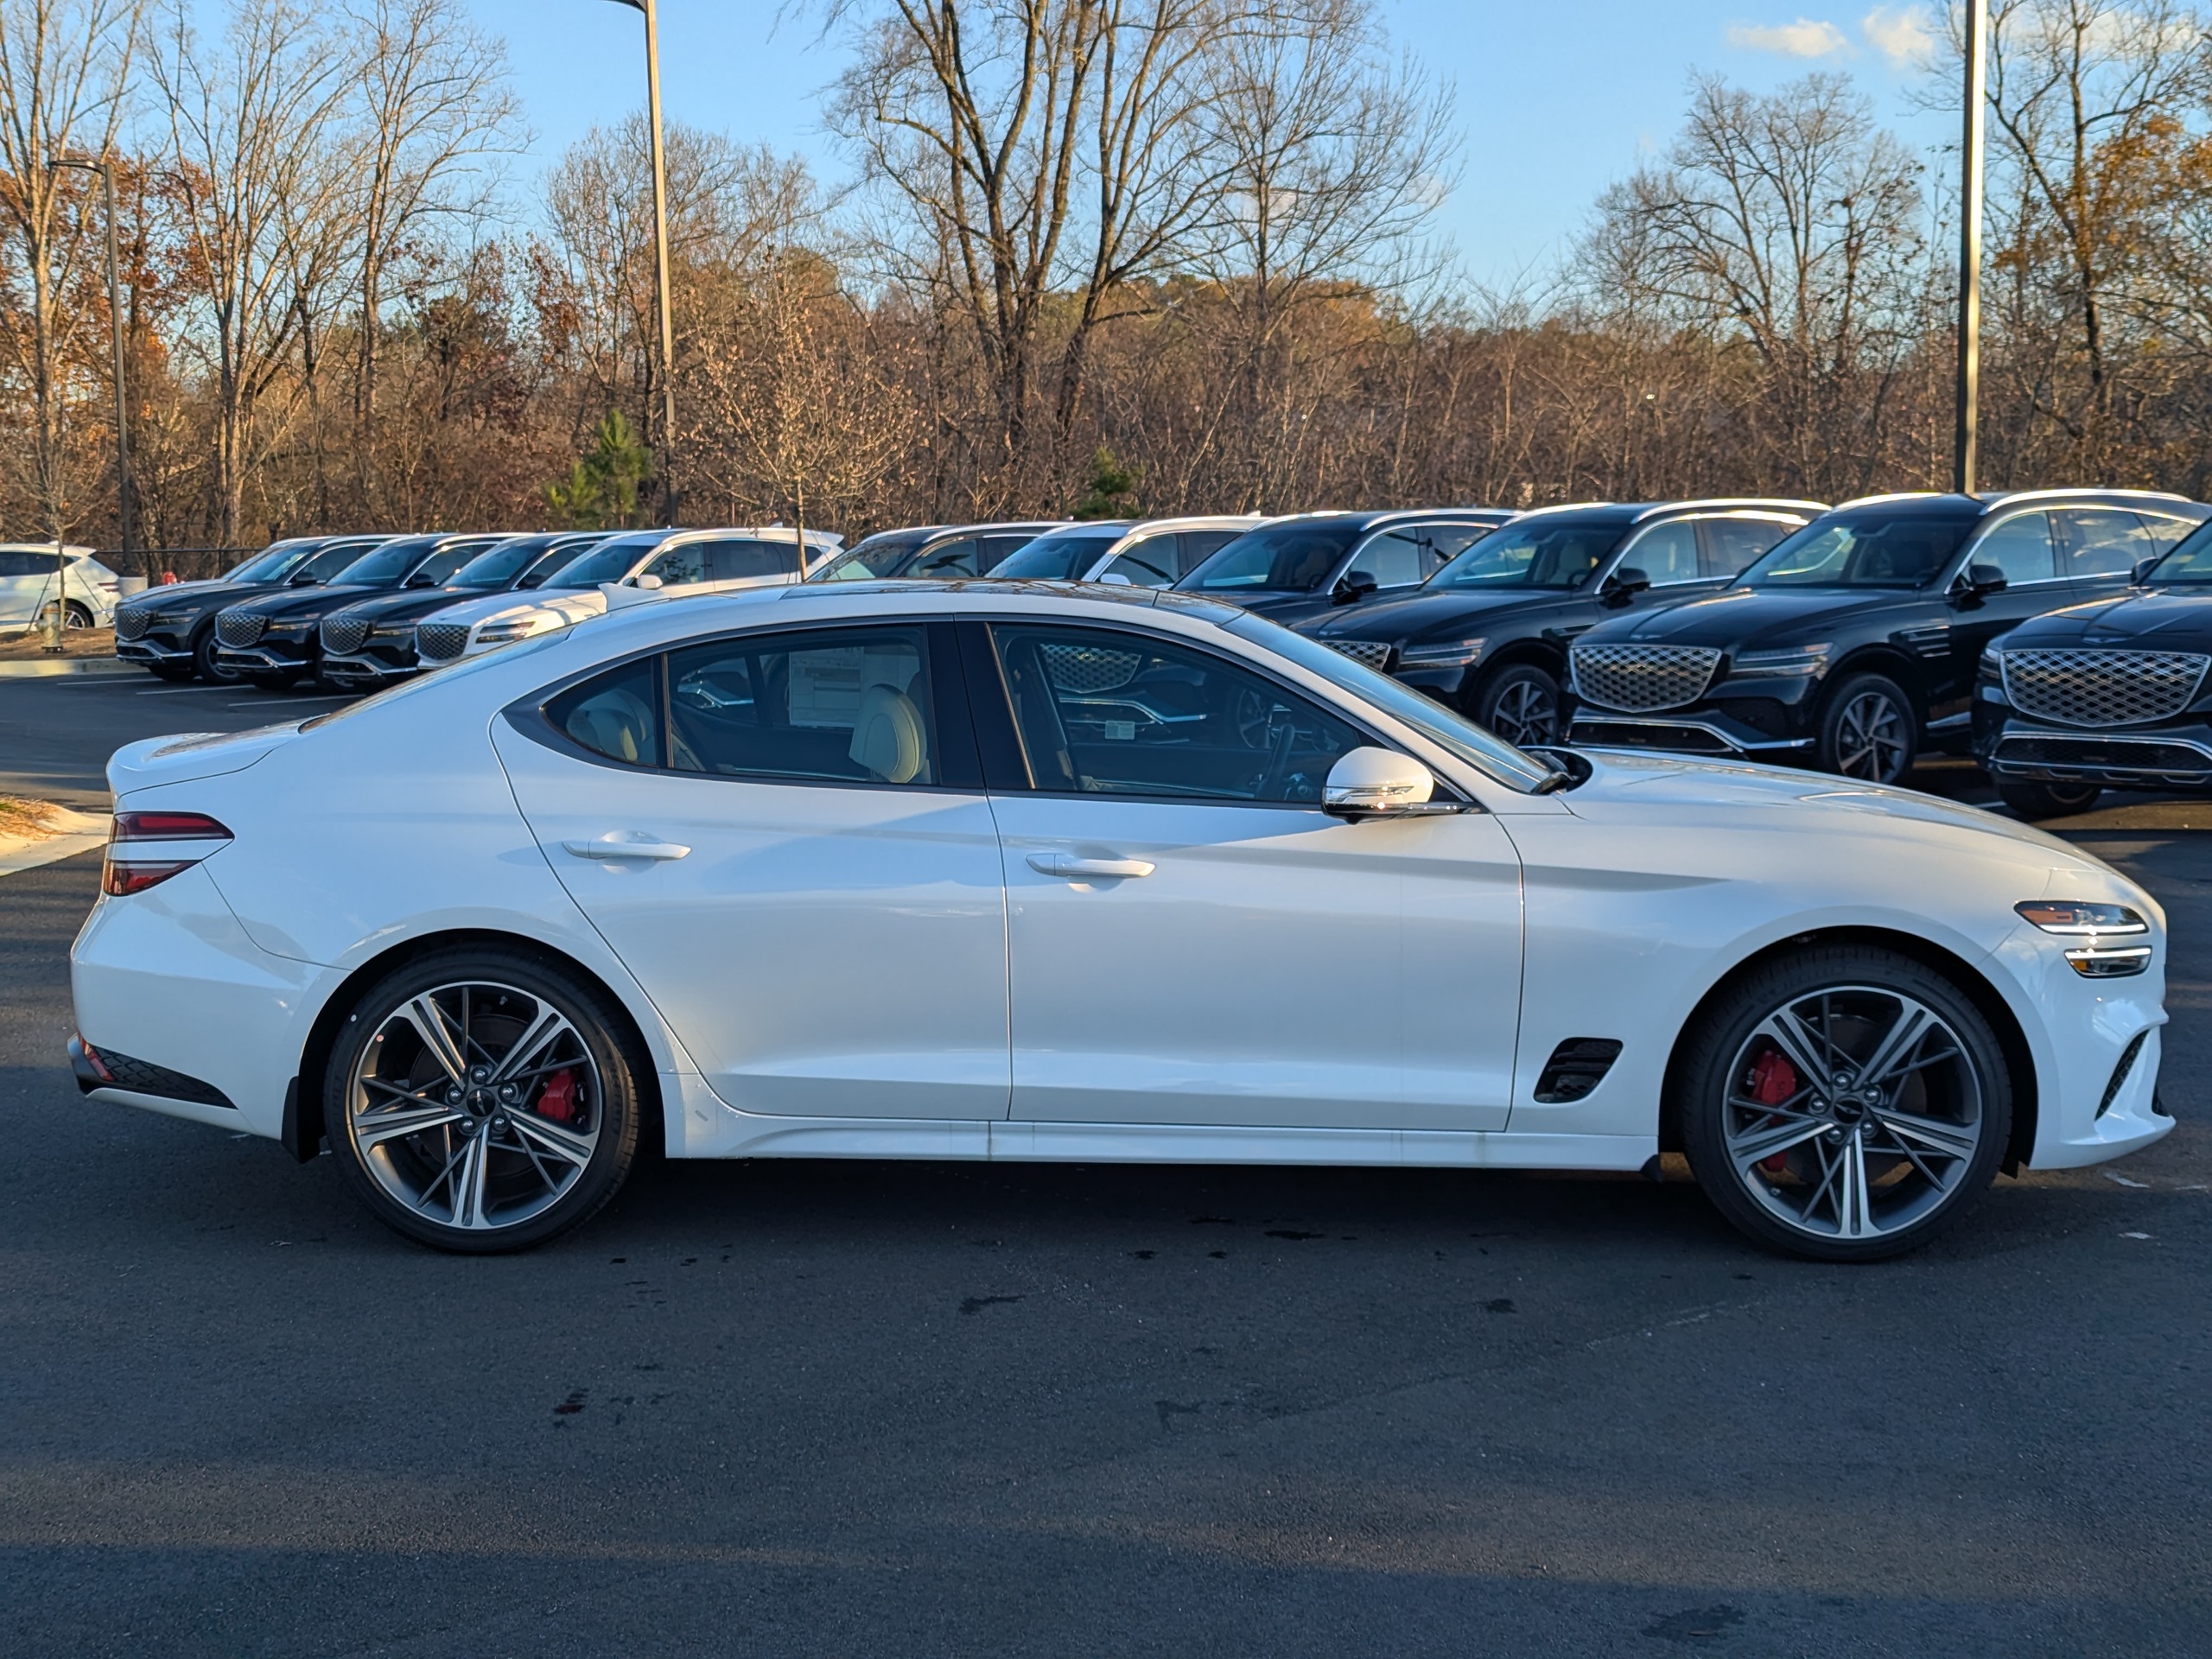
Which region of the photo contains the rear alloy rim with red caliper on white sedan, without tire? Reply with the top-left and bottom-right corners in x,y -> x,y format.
345,980 -> 604,1232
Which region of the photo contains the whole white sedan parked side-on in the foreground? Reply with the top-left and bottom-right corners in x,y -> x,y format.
73,582 -> 2172,1261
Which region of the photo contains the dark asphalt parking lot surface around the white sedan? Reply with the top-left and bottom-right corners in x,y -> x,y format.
0,677 -> 2212,1655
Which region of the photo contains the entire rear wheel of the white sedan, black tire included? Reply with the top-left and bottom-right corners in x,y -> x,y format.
323,949 -> 652,1255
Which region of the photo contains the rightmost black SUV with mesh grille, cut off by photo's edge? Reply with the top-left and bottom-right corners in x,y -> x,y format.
1974,524 -> 2212,818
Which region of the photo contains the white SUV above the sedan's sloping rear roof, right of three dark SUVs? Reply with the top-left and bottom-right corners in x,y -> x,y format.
416,524 -> 845,668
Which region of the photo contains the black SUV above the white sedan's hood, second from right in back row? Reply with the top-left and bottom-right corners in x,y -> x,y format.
1568,489 -> 2212,783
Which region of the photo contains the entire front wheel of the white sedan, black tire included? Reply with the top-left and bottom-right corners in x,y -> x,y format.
1668,944 -> 2013,1261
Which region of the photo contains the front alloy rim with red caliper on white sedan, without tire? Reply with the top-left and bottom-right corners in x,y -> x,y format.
1721,984 -> 1986,1243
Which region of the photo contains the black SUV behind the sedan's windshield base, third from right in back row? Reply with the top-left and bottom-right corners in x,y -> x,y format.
1299,500 -> 1827,743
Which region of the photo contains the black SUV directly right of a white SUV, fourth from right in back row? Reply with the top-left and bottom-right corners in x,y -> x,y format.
1174,506 -> 1513,628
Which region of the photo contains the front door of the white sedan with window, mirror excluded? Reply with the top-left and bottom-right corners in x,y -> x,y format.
964,621 -> 1522,1130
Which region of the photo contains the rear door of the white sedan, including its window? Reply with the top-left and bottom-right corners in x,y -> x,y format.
493,621 -> 1008,1119
